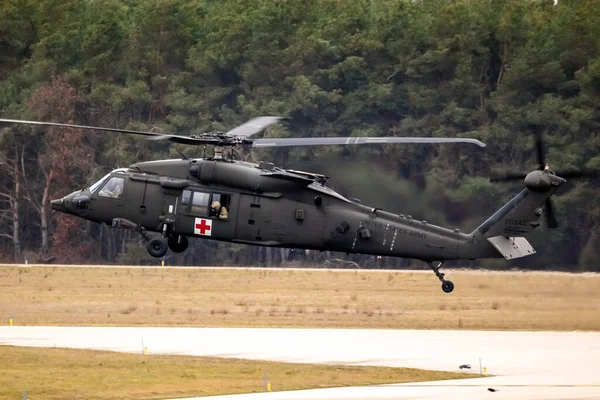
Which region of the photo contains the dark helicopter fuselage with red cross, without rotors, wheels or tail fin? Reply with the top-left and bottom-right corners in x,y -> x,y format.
53,159 -> 496,261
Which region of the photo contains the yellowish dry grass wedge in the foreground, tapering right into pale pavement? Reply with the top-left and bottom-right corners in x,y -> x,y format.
0,346 -> 474,400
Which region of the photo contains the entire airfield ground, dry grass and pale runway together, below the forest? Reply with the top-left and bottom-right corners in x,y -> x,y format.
0,266 -> 600,399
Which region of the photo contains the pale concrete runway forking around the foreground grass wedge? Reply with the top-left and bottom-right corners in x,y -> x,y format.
0,327 -> 600,400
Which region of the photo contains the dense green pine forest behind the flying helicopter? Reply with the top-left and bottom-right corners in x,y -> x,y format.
0,0 -> 600,271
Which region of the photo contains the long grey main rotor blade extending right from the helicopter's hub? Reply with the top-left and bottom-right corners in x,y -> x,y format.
251,136 -> 486,147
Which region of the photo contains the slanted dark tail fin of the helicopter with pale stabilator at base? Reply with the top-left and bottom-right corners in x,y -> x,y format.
470,169 -> 566,259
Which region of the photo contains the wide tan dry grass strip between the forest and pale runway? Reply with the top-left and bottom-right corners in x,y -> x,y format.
0,266 -> 600,330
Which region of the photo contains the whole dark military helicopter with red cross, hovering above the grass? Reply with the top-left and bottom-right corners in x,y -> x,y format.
0,117 -> 576,293
